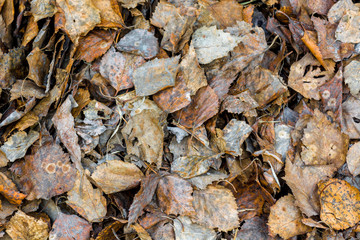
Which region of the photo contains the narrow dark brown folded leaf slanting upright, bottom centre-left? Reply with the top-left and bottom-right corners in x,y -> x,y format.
128,174 -> 161,225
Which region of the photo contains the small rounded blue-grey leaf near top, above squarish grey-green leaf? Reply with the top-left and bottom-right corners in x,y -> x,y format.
116,29 -> 159,59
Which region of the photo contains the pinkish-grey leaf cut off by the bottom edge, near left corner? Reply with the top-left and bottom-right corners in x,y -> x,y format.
49,212 -> 92,240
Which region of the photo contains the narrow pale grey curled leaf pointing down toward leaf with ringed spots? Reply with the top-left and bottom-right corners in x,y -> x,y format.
52,95 -> 83,171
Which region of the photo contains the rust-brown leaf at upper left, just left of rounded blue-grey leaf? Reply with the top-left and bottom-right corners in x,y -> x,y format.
75,29 -> 115,62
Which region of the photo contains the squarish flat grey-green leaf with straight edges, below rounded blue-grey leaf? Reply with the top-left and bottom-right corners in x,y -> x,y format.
133,56 -> 180,96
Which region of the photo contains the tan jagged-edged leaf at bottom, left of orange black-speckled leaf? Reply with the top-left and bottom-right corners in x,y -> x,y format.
268,194 -> 311,239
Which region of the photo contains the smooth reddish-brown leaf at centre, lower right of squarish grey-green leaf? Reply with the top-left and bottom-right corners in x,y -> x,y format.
174,86 -> 219,128
